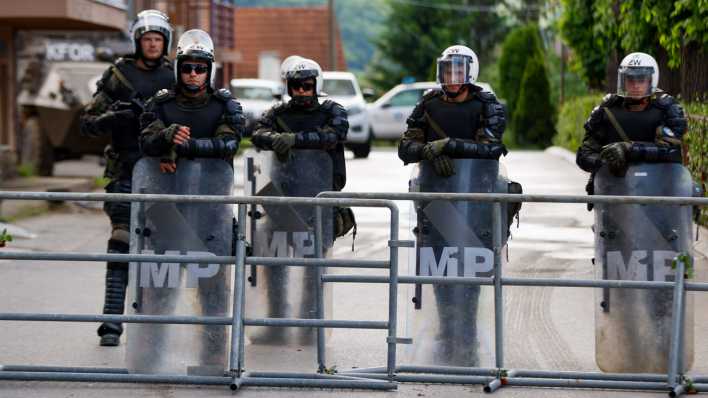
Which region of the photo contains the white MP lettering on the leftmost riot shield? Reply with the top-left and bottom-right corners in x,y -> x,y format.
140,250 -> 220,289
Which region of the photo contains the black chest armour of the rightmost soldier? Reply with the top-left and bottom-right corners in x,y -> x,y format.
605,104 -> 664,144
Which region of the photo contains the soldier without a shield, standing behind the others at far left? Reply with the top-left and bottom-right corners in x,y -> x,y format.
81,10 -> 174,346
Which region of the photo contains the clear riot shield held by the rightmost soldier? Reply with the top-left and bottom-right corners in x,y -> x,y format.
594,163 -> 693,373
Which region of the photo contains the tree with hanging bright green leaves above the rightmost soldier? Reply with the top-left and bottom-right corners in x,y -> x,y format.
560,0 -> 708,99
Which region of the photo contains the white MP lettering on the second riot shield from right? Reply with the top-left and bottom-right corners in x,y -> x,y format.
418,246 -> 494,277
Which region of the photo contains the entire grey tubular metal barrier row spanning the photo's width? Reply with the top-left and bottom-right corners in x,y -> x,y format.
0,192 -> 708,396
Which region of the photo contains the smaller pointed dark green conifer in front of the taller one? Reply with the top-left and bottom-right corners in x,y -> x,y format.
511,53 -> 556,148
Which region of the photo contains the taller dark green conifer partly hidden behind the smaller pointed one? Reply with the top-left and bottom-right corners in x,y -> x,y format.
499,24 -> 543,119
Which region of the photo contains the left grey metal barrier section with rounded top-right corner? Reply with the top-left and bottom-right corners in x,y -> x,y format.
0,192 -> 406,390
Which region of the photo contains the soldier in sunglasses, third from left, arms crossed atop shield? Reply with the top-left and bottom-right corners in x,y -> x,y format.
253,57 -> 354,236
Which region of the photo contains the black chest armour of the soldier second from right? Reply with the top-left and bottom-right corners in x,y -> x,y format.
425,97 -> 483,141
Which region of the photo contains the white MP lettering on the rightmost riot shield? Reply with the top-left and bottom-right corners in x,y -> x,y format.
605,250 -> 678,282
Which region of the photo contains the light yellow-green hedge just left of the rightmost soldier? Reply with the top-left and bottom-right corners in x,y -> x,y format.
553,93 -> 602,152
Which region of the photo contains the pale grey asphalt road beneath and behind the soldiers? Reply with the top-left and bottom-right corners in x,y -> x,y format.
0,149 -> 708,398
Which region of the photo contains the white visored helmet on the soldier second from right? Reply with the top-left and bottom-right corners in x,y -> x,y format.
435,45 -> 479,86
